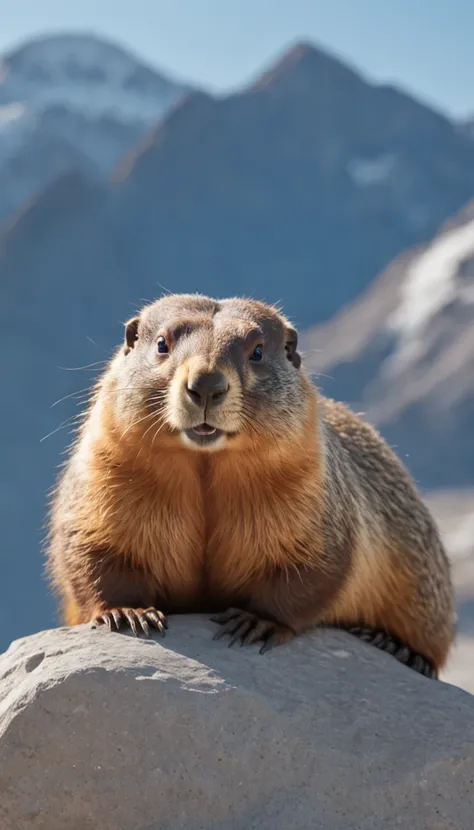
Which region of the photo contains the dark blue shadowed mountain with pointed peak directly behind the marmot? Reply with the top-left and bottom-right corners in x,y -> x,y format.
0,39 -> 474,646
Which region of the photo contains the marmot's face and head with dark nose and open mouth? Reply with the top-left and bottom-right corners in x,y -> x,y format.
109,295 -> 305,452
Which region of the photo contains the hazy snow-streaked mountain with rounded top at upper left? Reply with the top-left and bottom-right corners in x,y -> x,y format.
0,34 -> 187,219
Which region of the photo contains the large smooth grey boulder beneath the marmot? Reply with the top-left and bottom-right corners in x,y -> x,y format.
0,617 -> 474,830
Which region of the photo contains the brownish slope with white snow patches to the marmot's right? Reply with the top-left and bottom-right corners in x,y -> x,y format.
304,202 -> 474,488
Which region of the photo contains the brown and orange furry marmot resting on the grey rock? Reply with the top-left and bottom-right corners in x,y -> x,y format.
49,295 -> 454,677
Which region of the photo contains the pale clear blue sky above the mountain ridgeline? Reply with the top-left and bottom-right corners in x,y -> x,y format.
0,0 -> 474,115
